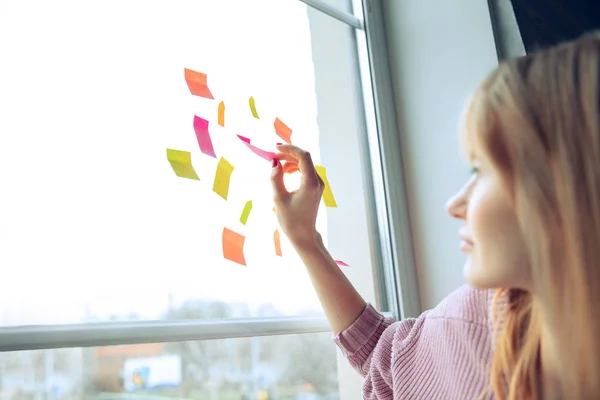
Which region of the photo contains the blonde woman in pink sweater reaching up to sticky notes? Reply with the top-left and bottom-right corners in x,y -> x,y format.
272,35 -> 600,399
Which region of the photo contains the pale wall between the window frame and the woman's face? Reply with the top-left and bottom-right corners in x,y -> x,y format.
383,0 -> 497,309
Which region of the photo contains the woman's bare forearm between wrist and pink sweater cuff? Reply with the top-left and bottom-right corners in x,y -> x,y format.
296,235 -> 366,335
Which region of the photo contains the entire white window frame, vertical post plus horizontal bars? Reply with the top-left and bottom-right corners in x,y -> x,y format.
0,0 -> 420,400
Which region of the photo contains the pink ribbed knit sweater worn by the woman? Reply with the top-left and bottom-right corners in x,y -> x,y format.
334,286 -> 493,400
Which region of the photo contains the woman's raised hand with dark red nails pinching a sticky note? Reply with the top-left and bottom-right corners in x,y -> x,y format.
271,144 -> 325,249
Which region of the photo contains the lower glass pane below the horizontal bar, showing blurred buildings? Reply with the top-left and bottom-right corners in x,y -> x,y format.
0,333 -> 339,400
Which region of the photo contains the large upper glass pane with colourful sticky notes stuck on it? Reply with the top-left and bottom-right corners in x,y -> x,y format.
0,0 -> 370,326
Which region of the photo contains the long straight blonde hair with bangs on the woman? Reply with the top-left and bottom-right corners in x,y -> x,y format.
462,34 -> 600,400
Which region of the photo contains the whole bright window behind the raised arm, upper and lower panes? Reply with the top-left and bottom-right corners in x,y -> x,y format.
0,0 -> 408,400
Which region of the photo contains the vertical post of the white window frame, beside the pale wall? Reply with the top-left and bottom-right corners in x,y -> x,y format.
352,0 -> 421,320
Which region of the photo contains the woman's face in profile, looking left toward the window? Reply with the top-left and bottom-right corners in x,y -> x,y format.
446,128 -> 531,289
